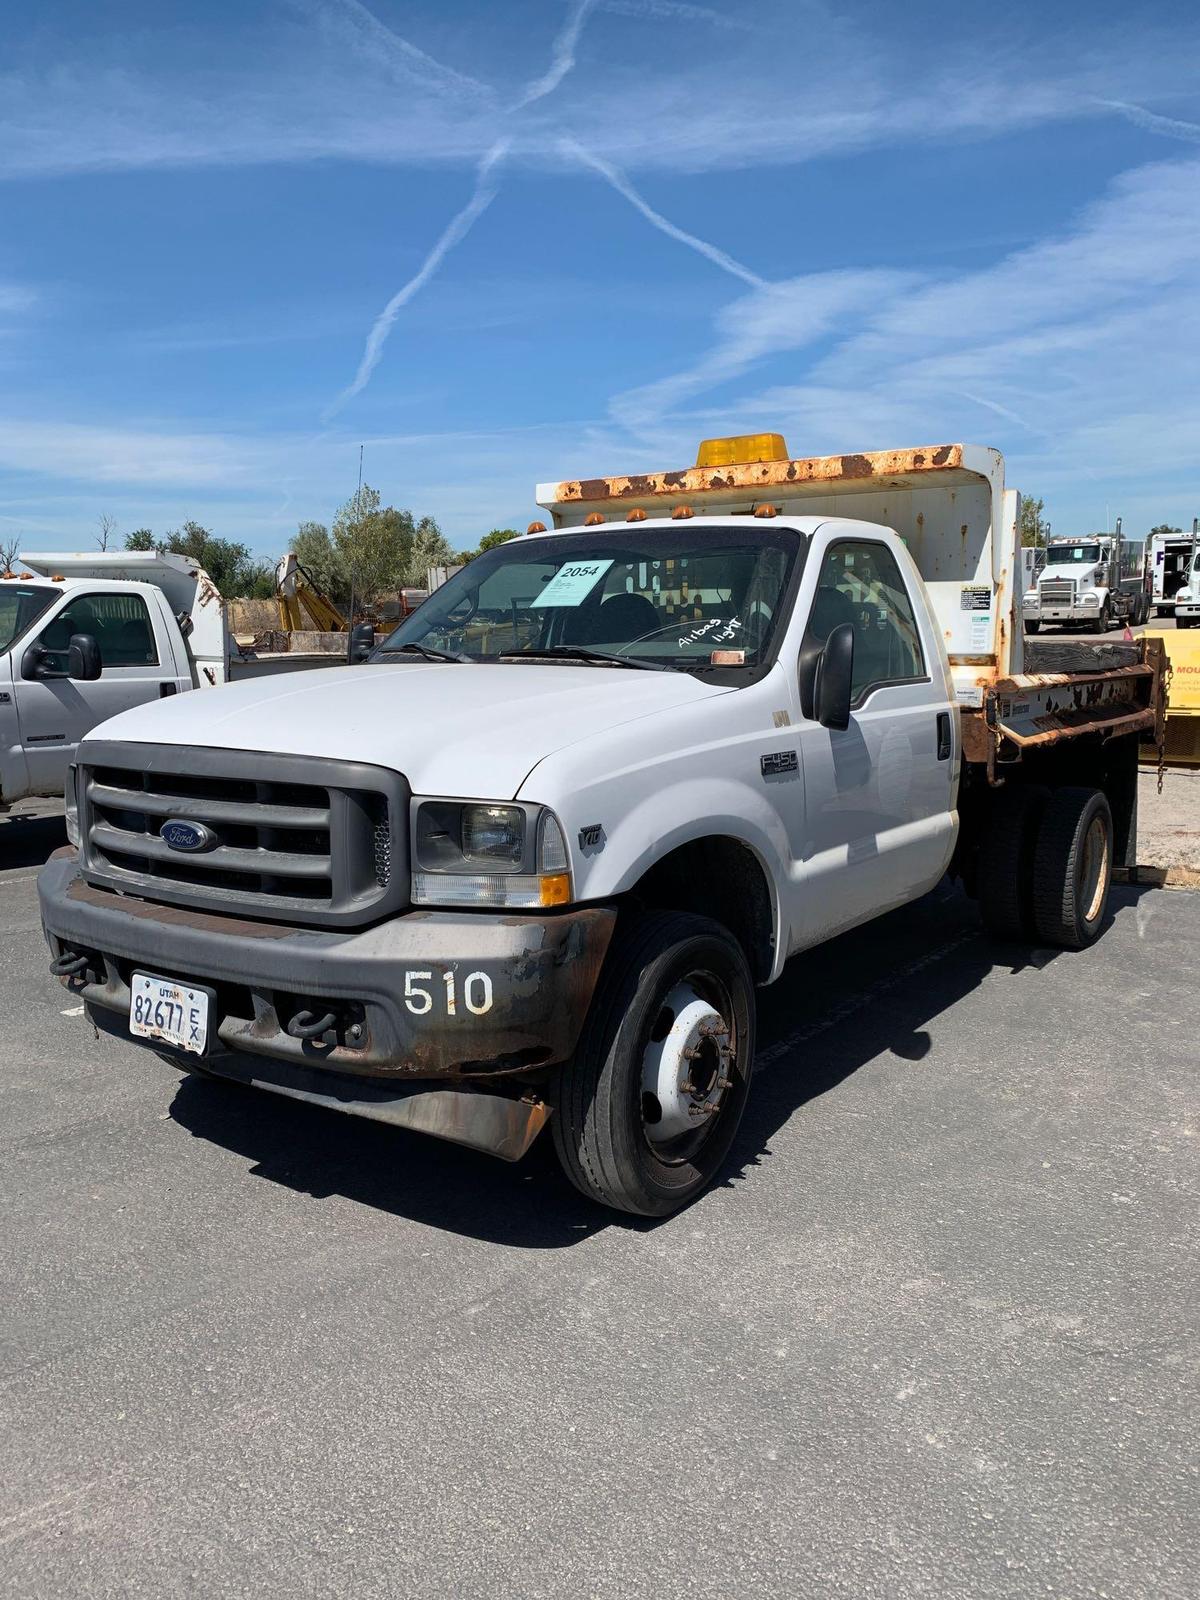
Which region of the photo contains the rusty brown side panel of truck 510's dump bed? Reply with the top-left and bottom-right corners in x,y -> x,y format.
962,638 -> 1168,782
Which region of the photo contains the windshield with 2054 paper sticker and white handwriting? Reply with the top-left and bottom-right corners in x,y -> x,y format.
376,526 -> 800,672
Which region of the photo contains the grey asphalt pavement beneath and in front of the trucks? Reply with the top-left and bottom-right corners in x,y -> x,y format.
0,818 -> 1200,1600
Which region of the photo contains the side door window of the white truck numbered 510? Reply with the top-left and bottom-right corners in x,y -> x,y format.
805,539 -> 928,706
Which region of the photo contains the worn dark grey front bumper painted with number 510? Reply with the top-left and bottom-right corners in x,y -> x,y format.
38,850 -> 616,1142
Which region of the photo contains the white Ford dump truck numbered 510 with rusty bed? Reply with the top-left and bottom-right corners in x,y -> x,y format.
40,435 -> 1162,1214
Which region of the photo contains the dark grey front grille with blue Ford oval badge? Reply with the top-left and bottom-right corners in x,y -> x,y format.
80,741 -> 408,926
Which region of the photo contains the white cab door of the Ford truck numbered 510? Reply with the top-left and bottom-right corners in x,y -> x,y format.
794,530 -> 958,949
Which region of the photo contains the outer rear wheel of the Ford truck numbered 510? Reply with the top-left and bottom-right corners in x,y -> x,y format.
1034,789 -> 1112,950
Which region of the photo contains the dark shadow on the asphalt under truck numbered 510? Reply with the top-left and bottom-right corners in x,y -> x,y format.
171,883 -> 1147,1250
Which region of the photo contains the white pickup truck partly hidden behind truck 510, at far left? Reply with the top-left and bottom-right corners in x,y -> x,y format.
0,550 -> 344,813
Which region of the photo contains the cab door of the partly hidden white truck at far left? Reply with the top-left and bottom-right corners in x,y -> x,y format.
13,590 -> 178,795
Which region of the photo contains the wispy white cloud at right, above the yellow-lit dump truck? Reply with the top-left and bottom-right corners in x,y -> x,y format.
620,160 -> 1200,531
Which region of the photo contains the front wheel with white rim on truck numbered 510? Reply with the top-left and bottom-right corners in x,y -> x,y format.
550,912 -> 755,1216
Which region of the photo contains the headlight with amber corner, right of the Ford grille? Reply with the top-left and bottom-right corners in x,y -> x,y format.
413,800 -> 571,910
